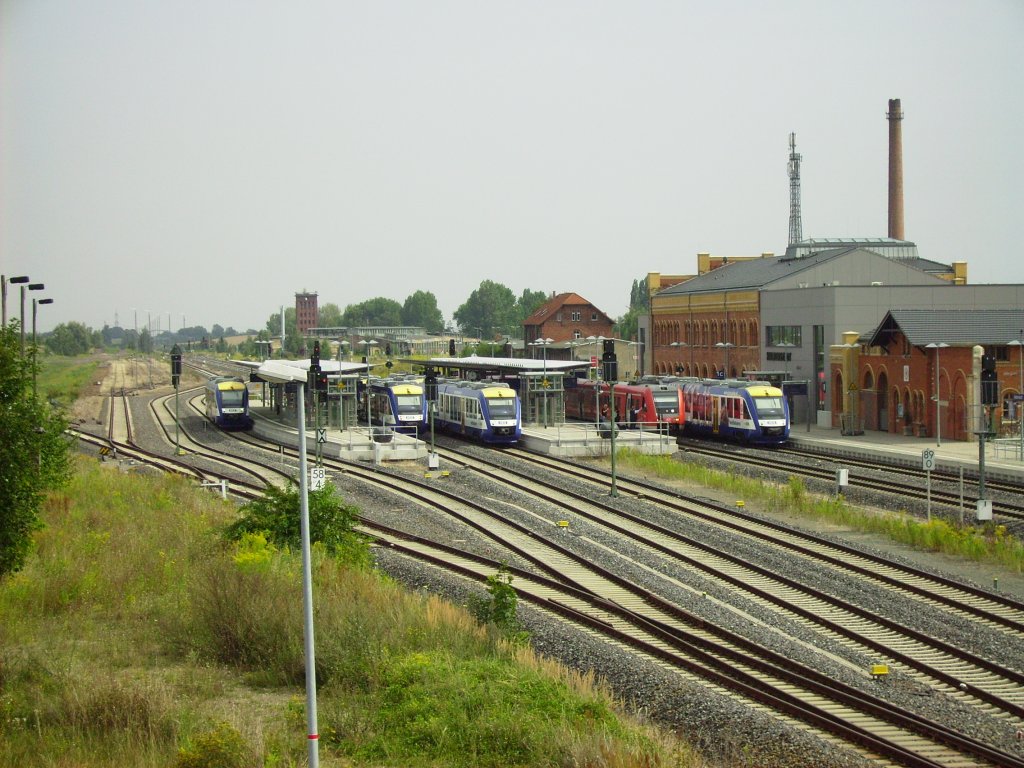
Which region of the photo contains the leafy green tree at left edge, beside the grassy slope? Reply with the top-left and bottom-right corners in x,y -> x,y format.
0,322 -> 71,575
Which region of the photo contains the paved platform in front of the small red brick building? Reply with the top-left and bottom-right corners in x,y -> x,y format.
790,424 -> 1024,485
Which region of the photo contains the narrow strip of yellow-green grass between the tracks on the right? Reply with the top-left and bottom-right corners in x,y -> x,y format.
617,449 -> 1024,573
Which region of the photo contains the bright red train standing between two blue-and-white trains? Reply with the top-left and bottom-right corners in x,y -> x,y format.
565,377 -> 684,430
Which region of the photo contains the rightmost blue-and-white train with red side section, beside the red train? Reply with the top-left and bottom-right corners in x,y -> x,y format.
680,379 -> 790,445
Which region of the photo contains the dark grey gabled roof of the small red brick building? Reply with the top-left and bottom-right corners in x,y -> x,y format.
867,309 -> 1024,347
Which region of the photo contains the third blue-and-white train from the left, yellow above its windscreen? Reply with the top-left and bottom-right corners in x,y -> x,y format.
434,381 -> 522,445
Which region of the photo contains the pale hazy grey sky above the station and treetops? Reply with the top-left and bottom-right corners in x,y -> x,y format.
0,0 -> 1024,330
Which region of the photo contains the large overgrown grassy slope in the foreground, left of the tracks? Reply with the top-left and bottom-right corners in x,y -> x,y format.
0,459 -> 700,768
